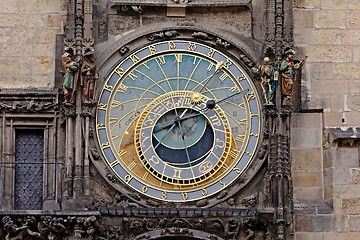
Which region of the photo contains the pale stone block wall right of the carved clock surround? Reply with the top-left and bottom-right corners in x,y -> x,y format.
292,0 -> 360,240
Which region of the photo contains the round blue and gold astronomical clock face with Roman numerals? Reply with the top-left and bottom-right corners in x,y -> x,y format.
96,40 -> 262,202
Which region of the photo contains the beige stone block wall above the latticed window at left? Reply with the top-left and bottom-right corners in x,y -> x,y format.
0,0 -> 67,89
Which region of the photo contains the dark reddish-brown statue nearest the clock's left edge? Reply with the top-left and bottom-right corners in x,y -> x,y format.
80,49 -> 99,104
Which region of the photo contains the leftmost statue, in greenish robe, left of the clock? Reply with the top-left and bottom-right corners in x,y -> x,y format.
60,48 -> 78,103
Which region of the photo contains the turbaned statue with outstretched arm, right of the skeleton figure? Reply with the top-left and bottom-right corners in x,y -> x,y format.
280,49 -> 307,105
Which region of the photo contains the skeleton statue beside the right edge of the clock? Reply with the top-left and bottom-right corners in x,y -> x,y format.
258,57 -> 277,105
